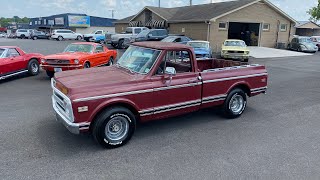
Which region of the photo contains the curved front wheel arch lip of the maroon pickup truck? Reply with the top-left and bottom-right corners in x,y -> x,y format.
89,98 -> 139,126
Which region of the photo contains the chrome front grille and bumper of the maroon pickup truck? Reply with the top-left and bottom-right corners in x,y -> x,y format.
51,78 -> 90,134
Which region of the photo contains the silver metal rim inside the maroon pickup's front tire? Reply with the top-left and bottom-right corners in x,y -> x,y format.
105,116 -> 129,141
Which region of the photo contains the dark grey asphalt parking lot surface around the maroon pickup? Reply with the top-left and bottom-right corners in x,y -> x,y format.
0,39 -> 320,180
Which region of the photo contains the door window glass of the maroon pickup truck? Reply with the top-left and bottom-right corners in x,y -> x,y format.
156,51 -> 192,75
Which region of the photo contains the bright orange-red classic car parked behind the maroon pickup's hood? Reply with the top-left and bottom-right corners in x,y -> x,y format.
41,42 -> 117,77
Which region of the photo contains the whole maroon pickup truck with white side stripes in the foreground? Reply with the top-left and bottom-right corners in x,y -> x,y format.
52,42 -> 268,148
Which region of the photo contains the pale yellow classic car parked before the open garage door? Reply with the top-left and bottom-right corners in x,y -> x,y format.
221,39 -> 250,62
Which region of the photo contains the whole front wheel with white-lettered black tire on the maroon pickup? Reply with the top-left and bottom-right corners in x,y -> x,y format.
92,107 -> 136,148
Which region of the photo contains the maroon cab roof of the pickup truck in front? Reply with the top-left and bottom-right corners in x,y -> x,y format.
133,41 -> 192,50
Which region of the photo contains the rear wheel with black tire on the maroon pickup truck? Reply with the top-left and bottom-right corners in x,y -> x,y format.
223,88 -> 247,119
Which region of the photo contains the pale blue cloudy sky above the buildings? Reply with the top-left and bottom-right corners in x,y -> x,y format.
0,0 -> 317,21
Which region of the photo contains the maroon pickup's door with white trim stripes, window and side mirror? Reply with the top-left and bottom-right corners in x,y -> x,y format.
152,50 -> 202,119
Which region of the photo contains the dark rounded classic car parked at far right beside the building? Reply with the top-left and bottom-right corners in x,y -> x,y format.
288,36 -> 319,53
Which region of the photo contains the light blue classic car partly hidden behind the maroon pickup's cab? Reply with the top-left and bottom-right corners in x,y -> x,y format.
187,41 -> 212,59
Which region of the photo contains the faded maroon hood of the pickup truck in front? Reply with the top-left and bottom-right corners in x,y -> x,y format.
55,66 -> 142,99
